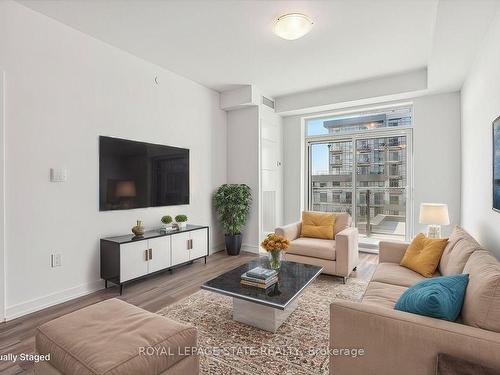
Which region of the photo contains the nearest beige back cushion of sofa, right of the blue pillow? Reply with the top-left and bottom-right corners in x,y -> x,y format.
462,250 -> 500,332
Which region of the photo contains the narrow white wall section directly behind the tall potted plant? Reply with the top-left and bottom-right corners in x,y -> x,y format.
227,106 -> 260,252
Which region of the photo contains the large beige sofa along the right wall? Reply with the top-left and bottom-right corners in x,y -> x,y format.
330,227 -> 500,375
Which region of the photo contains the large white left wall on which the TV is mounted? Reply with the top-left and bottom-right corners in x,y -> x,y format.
0,1 -> 226,317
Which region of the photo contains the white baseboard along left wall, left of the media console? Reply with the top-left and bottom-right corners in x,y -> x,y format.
5,280 -> 104,321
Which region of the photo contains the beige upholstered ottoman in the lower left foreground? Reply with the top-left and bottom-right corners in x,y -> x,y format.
35,298 -> 199,375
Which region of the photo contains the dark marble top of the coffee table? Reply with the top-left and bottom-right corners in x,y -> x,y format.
202,257 -> 323,310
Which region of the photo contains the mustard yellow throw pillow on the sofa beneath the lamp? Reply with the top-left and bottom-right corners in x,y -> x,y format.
400,233 -> 448,277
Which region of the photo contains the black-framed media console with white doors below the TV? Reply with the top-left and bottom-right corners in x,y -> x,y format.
101,225 -> 209,295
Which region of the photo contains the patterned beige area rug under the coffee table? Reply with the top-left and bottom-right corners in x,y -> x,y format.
158,275 -> 367,375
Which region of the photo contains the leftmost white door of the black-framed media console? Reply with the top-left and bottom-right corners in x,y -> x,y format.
120,241 -> 148,283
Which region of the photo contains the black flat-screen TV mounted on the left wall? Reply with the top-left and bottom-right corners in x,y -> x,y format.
99,136 -> 189,211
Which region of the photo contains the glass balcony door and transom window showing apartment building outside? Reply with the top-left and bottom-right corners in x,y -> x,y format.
306,106 -> 412,239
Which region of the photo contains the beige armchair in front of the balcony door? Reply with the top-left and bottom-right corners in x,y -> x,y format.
275,213 -> 359,283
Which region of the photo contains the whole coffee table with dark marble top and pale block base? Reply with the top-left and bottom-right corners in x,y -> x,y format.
201,257 -> 323,332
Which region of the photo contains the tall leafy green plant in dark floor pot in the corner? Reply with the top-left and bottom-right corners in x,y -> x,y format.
214,184 -> 252,255
